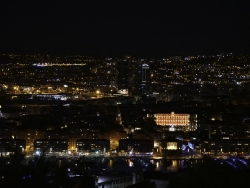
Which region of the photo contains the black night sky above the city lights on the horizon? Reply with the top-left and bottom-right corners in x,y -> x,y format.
0,0 -> 250,57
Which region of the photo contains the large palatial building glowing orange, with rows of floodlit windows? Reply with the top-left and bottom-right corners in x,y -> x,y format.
154,112 -> 197,131
